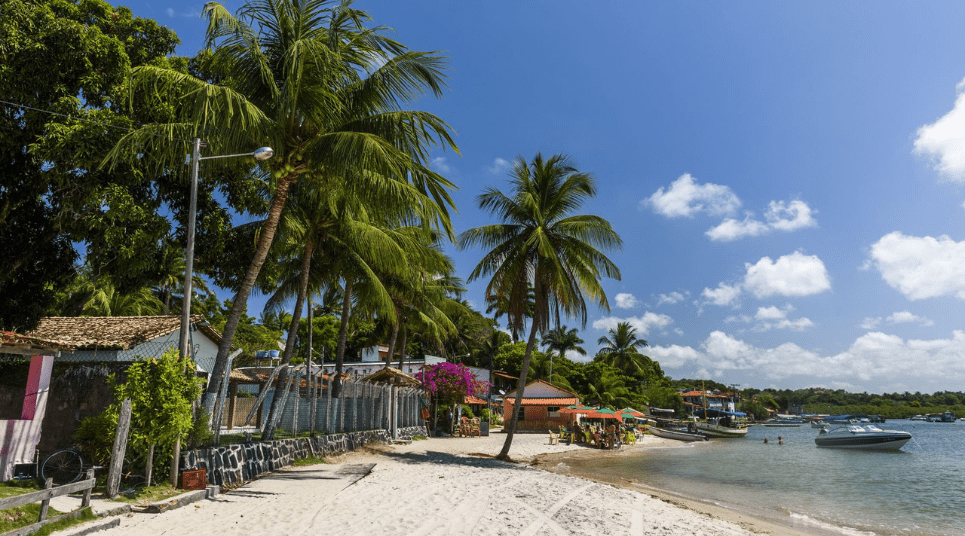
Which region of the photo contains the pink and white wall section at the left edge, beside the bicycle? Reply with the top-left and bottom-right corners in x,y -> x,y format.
0,355 -> 54,482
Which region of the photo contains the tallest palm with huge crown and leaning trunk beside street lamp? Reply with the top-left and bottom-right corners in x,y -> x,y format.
108,0 -> 456,414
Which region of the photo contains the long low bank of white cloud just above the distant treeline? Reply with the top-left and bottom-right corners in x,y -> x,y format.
647,330 -> 965,392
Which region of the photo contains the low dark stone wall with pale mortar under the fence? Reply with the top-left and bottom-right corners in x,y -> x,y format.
181,426 -> 428,490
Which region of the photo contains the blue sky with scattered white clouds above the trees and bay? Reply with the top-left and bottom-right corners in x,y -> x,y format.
141,0 -> 965,393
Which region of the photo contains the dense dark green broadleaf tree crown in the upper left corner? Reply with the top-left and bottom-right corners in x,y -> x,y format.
0,0 -> 185,330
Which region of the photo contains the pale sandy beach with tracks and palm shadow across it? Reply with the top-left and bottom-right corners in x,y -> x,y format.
81,433 -> 801,536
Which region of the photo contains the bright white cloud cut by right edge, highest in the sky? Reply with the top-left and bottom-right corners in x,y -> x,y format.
914,75 -> 965,182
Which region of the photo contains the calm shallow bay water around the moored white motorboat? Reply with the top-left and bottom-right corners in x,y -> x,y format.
564,420 -> 965,536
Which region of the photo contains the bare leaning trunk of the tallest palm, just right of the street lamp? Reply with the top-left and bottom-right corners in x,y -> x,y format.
204,174 -> 297,422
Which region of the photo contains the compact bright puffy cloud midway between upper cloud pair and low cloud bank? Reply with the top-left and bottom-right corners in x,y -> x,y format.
744,251 -> 831,298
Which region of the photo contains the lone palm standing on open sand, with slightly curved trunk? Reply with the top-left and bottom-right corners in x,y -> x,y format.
459,154 -> 621,460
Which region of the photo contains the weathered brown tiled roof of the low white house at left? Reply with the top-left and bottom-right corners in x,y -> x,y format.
26,315 -> 221,350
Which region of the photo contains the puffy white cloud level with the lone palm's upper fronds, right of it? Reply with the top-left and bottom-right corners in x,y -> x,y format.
640,173 -> 741,218
